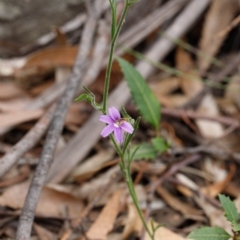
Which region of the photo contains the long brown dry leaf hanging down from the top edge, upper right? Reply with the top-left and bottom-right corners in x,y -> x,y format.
198,0 -> 239,72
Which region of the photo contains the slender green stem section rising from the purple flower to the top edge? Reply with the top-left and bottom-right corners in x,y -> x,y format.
103,0 -> 129,114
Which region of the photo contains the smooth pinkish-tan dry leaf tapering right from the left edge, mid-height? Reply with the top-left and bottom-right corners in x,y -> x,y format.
0,110 -> 43,127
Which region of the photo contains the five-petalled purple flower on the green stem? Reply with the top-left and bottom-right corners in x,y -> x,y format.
99,107 -> 134,143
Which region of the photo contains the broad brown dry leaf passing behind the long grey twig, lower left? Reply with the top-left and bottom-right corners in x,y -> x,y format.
0,182 -> 83,218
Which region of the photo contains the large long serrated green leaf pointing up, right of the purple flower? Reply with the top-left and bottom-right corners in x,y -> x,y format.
117,58 -> 161,129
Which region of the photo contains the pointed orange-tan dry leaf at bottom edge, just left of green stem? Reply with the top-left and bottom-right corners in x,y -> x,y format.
86,190 -> 123,240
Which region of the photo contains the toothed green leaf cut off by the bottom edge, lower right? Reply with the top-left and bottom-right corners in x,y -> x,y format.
188,227 -> 231,240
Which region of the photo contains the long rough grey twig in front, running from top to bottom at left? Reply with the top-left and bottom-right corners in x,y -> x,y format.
16,1 -> 98,240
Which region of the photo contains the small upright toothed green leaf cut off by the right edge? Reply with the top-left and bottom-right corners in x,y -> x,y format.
218,194 -> 238,226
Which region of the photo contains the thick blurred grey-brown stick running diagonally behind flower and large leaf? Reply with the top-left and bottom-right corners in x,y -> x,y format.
47,0 -> 210,183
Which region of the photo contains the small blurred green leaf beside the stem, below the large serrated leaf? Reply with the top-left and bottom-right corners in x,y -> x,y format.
130,143 -> 158,161
